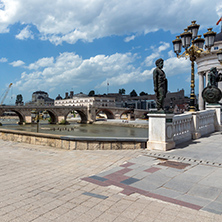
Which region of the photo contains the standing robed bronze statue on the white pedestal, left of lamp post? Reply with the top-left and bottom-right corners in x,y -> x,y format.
153,58 -> 168,111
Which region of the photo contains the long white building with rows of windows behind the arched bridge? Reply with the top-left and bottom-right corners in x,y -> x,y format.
54,93 -> 116,107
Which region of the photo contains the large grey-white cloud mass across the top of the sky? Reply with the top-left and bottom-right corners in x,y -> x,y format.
0,0 -> 222,44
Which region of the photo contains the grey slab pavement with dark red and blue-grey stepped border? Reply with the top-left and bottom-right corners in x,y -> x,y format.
83,133 -> 222,214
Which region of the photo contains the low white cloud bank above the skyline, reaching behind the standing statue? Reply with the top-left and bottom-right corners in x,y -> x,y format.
11,47 -> 190,92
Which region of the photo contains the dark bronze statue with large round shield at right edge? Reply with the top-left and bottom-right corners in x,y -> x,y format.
202,67 -> 222,104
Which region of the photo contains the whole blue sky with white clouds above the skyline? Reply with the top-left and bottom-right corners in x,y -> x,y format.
0,0 -> 222,104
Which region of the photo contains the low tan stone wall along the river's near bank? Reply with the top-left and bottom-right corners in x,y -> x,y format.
0,129 -> 147,150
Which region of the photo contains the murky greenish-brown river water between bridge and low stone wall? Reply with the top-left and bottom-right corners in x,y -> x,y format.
0,119 -> 148,138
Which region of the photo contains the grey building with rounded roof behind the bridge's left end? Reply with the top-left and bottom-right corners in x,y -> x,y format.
25,91 -> 54,106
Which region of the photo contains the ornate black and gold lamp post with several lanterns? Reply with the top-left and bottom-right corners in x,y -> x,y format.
173,21 -> 216,112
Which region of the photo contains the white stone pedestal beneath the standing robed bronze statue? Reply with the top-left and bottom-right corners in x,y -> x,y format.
147,113 -> 175,151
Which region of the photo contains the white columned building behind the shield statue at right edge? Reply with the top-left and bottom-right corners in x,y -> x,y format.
196,32 -> 222,110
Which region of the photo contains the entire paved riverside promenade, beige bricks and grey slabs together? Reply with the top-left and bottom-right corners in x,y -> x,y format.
0,132 -> 222,222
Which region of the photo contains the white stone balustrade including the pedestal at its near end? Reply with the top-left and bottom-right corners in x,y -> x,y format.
147,105 -> 221,151
